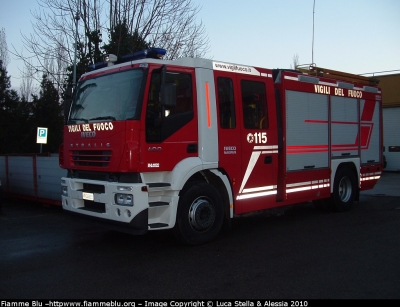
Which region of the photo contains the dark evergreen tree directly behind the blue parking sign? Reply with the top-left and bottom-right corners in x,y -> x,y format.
30,75 -> 64,153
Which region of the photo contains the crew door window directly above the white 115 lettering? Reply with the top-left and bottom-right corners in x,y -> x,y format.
240,80 -> 268,129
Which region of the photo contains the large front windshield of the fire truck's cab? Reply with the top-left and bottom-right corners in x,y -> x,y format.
69,69 -> 144,122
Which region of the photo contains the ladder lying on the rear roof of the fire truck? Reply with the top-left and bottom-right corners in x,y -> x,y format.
296,65 -> 379,86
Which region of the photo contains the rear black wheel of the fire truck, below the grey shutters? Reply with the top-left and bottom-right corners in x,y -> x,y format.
331,167 -> 357,212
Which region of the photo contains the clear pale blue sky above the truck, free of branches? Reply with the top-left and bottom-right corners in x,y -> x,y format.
0,0 -> 400,89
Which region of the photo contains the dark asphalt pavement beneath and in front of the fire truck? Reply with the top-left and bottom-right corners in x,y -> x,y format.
0,172 -> 400,300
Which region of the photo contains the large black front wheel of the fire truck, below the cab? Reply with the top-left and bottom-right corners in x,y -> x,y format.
174,183 -> 224,245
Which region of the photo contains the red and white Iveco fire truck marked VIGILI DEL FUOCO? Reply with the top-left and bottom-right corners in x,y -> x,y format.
59,48 -> 382,244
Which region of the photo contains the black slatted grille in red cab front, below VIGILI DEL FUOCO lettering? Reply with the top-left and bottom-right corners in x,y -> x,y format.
72,150 -> 111,167
